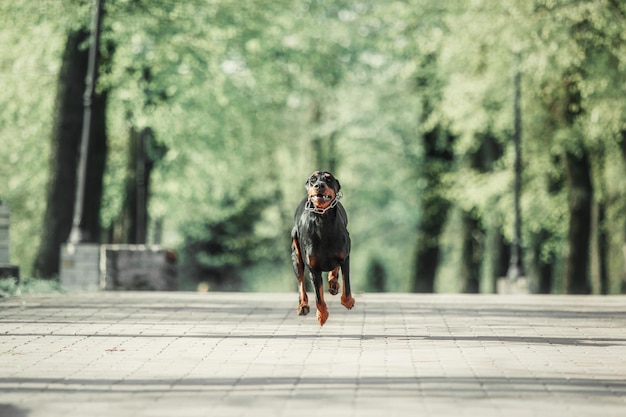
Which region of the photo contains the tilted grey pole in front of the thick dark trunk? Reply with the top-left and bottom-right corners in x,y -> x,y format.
69,0 -> 104,243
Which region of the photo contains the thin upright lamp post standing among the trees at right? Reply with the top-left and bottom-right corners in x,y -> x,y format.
506,59 -> 524,279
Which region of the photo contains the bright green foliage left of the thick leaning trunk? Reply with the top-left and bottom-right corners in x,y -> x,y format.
0,1 -> 88,275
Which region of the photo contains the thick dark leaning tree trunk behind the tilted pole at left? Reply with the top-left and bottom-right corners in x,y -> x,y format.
34,29 -> 107,278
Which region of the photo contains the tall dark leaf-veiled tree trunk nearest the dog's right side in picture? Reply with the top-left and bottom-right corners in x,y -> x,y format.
411,129 -> 453,293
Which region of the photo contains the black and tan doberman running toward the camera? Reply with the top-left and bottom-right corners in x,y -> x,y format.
291,171 -> 354,325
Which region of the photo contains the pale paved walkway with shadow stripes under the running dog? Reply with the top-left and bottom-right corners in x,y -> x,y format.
0,292 -> 626,417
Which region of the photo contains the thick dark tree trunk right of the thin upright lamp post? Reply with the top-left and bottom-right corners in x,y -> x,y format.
565,150 -> 593,294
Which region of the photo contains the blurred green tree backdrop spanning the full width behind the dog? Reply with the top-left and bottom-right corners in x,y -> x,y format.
0,0 -> 626,293
